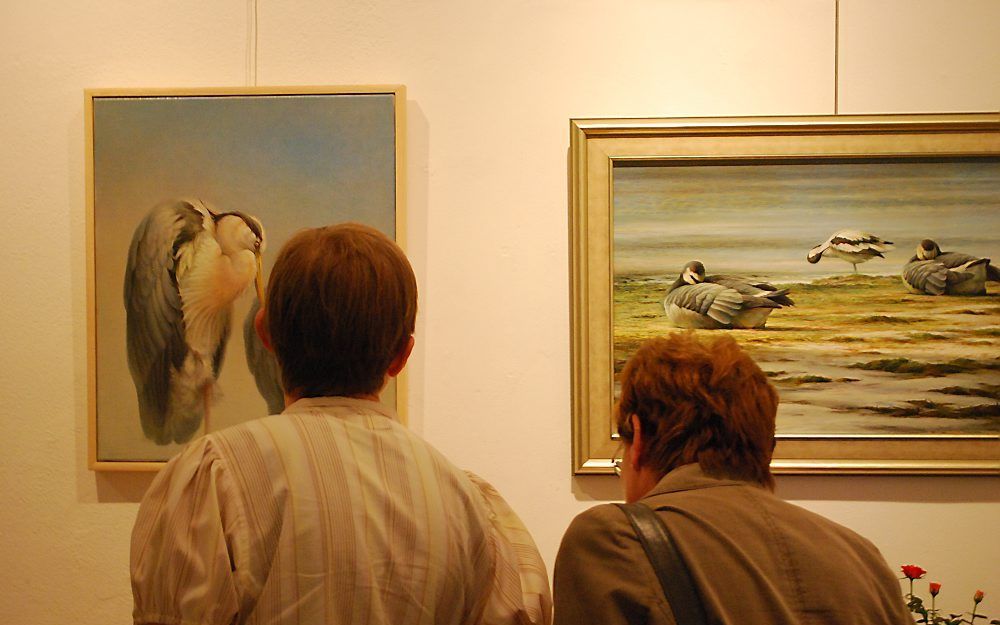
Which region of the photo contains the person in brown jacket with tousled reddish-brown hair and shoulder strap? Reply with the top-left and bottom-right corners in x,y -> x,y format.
553,332 -> 912,625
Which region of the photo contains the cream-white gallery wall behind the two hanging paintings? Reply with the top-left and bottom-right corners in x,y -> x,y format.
0,0 -> 1000,624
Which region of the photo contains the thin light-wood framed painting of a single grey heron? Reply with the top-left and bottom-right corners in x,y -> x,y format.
84,85 -> 406,470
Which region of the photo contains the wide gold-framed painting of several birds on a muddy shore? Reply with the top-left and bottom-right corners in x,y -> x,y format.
570,113 -> 1000,475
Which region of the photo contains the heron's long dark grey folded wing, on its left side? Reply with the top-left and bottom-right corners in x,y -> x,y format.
124,201 -> 203,440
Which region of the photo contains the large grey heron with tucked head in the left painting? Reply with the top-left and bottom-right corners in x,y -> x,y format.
125,200 -> 265,445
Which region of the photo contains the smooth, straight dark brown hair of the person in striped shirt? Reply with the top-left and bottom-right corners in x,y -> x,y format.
265,223 -> 417,397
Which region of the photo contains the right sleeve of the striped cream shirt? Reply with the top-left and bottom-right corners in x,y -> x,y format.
466,471 -> 552,625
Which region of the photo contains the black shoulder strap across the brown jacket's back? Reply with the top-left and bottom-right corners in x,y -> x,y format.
617,503 -> 707,625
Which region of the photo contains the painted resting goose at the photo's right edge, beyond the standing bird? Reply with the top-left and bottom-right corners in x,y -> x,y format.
903,239 -> 1000,295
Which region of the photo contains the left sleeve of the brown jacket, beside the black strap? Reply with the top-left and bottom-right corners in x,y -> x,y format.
553,504 -> 674,625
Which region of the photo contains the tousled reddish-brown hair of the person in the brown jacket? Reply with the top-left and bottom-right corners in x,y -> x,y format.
615,332 -> 778,488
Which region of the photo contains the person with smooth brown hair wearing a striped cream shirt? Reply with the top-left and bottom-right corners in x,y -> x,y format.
131,224 -> 551,625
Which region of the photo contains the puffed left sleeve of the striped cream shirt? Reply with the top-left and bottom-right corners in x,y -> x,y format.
131,438 -> 241,625
